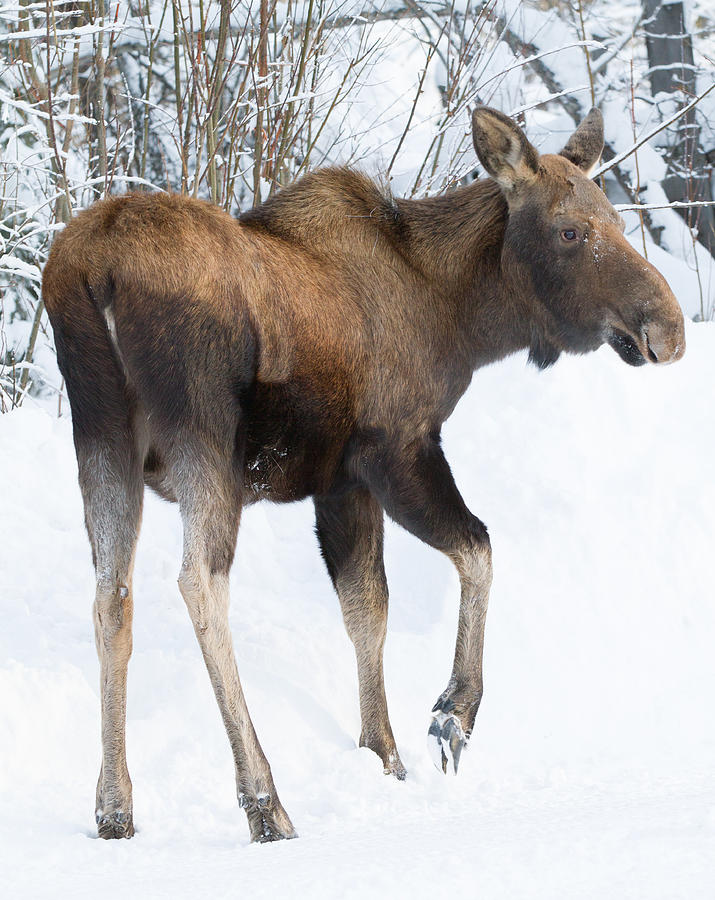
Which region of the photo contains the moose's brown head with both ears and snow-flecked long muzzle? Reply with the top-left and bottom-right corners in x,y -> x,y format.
472,107 -> 685,366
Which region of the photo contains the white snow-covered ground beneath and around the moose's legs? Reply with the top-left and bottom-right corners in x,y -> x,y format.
0,320 -> 715,900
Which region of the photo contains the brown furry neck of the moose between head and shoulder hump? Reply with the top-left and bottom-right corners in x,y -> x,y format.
395,180 -> 536,369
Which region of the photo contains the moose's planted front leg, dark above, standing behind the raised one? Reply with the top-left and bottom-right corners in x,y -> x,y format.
315,489 -> 405,780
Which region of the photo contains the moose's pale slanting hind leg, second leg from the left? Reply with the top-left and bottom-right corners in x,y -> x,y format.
177,460 -> 296,842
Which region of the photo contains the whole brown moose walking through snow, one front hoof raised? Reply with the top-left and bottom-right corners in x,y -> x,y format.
43,106 -> 685,842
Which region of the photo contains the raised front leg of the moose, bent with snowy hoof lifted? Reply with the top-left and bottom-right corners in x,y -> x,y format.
361,435 -> 492,773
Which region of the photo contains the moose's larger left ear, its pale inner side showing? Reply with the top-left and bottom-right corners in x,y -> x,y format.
472,106 -> 539,191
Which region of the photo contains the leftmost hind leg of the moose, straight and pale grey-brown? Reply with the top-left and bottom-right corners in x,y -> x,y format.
77,436 -> 144,839
